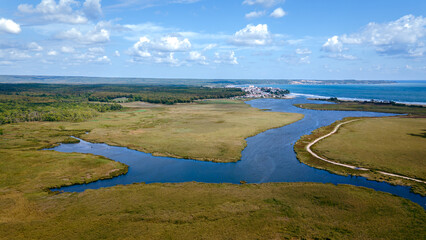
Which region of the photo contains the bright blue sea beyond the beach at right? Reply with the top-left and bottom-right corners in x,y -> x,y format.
255,80 -> 426,105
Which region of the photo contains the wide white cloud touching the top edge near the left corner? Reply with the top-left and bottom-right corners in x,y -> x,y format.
18,0 -> 88,24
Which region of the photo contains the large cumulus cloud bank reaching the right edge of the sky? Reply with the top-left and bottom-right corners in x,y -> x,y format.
323,15 -> 426,57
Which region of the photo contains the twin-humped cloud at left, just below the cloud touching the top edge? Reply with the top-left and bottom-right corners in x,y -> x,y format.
56,25 -> 110,44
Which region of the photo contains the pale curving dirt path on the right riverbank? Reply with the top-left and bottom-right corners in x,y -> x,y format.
306,119 -> 426,183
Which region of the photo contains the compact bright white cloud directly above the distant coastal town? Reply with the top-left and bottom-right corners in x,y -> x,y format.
232,24 -> 271,46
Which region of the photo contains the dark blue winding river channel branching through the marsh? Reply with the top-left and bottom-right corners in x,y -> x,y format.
50,97 -> 426,208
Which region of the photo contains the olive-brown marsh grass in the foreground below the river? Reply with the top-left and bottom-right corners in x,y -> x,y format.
0,183 -> 426,239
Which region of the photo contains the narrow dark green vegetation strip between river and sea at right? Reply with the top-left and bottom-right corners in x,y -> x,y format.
295,98 -> 426,116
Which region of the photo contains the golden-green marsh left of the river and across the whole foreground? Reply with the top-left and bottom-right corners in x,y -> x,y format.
0,84 -> 426,239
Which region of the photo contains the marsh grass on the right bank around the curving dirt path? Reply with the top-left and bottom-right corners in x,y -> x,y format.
294,117 -> 426,196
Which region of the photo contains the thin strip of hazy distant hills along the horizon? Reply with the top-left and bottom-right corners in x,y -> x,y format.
0,75 -> 395,86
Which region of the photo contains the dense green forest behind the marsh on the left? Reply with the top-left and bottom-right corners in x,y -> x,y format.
0,84 -> 244,124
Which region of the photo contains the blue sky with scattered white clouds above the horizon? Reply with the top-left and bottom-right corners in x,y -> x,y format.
0,0 -> 426,80
